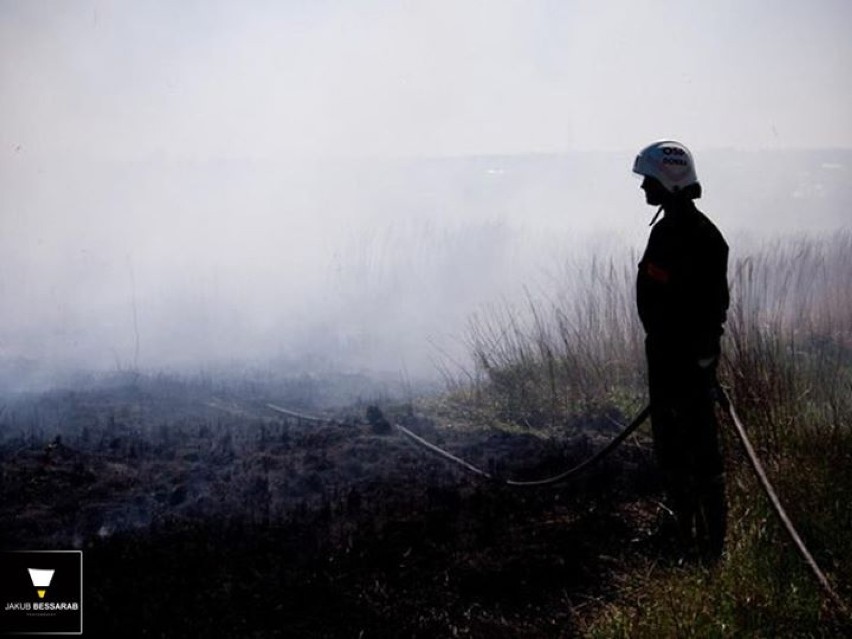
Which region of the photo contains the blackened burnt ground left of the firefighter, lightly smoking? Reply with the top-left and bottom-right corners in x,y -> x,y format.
0,380 -> 658,637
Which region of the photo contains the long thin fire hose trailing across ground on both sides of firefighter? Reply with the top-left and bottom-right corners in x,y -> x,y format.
267,398 -> 852,618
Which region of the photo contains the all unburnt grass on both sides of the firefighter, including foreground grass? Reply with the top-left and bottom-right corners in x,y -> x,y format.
457,232 -> 852,637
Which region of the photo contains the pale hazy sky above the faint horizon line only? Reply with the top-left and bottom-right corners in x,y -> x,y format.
0,0 -> 852,159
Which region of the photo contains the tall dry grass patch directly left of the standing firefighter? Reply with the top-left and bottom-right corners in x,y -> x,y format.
460,254 -> 644,428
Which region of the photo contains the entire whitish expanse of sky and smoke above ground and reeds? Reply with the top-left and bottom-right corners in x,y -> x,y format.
0,0 -> 852,381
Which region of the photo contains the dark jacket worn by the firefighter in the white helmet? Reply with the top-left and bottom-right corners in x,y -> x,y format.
636,200 -> 730,359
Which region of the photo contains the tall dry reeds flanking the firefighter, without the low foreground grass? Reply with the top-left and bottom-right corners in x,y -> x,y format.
466,232 -> 852,442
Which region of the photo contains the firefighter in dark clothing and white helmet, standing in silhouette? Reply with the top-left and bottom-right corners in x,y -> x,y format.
633,141 -> 729,560
